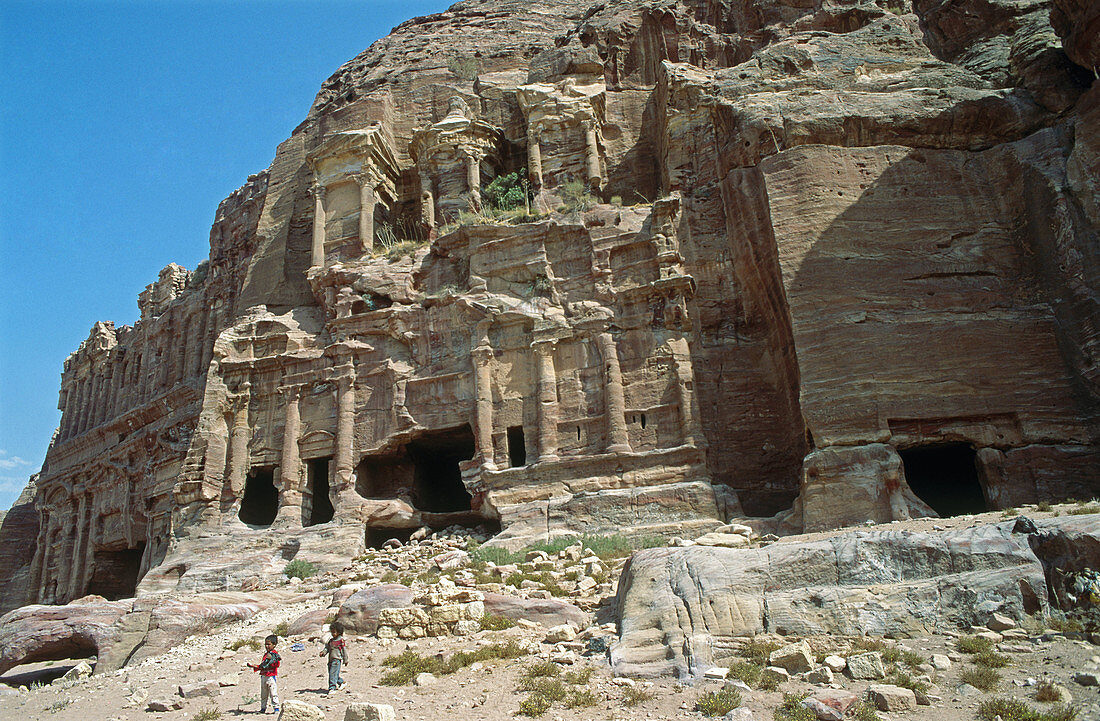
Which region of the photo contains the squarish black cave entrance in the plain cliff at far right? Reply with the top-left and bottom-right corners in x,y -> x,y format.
898,444 -> 989,517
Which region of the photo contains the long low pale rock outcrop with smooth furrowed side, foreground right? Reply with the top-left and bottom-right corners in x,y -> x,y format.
612,516 -> 1100,676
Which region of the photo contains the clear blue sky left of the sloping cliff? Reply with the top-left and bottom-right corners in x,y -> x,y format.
0,0 -> 450,509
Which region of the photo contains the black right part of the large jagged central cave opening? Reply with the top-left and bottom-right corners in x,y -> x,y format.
408,424 -> 474,513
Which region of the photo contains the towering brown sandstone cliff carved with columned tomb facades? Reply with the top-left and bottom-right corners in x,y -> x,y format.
10,0 -> 1100,603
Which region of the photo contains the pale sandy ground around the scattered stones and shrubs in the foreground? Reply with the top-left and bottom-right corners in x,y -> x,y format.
0,504 -> 1100,721
